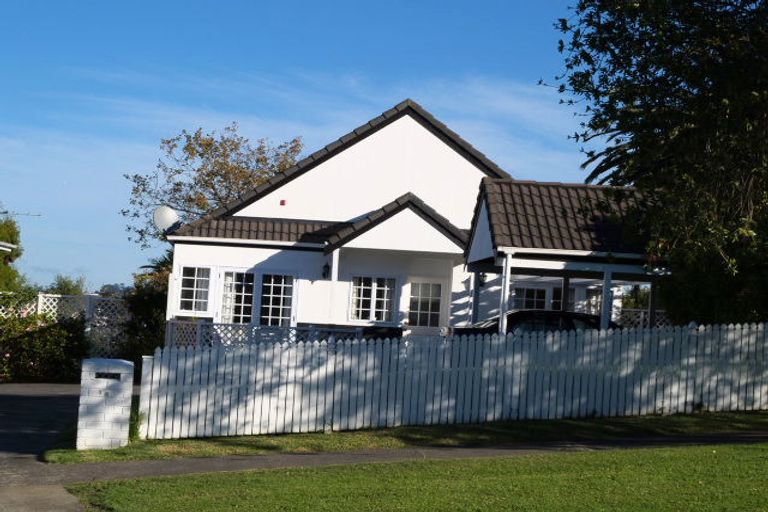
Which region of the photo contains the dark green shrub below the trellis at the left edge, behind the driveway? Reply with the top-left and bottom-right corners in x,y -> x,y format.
0,315 -> 88,382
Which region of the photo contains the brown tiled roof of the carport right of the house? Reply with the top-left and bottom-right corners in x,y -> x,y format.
472,178 -> 645,254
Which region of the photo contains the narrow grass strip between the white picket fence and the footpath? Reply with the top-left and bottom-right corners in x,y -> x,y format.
45,412 -> 768,463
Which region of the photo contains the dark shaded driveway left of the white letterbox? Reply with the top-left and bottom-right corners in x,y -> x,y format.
0,384 -> 80,459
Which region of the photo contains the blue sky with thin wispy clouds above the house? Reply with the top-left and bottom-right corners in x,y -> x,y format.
0,0 -> 584,289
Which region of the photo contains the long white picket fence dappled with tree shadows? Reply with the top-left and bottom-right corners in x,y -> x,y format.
140,324 -> 768,439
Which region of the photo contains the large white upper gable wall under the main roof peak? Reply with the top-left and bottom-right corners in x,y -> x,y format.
235,115 -> 485,229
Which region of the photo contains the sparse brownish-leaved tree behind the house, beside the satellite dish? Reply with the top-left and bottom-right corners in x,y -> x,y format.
120,123 -> 303,247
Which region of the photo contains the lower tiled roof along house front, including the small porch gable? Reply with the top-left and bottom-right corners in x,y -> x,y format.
169,193 -> 468,252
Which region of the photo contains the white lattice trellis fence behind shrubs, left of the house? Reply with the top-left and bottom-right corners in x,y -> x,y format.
0,293 -> 128,357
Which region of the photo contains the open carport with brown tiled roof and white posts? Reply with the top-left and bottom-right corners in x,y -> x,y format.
466,178 -> 666,333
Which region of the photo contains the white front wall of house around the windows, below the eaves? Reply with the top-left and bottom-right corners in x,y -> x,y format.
167,243 -> 471,326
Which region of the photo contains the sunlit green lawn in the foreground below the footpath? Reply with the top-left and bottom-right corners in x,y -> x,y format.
68,444 -> 768,512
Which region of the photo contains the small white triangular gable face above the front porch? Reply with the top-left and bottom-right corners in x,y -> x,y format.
344,208 -> 463,254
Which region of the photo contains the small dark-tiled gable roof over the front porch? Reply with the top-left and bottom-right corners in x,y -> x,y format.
325,192 -> 468,252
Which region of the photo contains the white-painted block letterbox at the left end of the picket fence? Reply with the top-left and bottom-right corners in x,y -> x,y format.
77,359 -> 133,450
